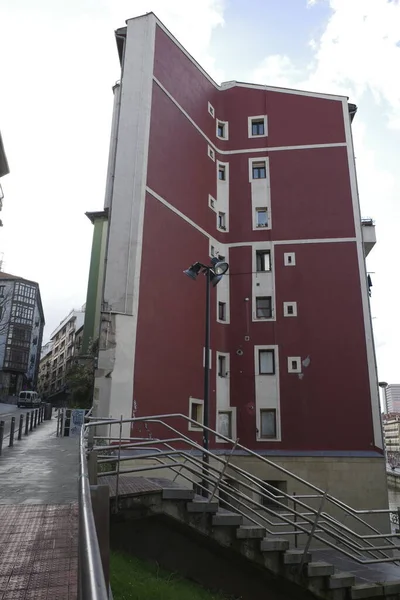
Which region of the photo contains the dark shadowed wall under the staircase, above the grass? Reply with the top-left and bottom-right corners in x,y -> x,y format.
110,515 -> 315,600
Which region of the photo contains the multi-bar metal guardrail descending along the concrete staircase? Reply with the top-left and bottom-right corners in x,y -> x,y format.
85,414 -> 400,564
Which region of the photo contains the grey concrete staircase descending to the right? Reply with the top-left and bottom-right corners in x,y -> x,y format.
108,477 -> 400,600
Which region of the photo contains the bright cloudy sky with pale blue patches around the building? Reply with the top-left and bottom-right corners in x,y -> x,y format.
0,0 -> 400,383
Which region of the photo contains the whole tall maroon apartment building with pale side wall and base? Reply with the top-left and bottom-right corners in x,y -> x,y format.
95,13 -> 387,508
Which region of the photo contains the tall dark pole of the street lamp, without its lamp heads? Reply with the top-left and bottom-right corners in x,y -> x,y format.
201,268 -> 211,498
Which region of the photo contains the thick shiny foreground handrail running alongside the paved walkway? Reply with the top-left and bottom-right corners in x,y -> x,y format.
78,427 -> 108,600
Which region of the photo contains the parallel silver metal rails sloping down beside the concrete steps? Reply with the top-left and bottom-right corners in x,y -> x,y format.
83,414 -> 400,564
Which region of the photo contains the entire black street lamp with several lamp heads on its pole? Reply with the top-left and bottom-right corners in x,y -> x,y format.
183,257 -> 229,497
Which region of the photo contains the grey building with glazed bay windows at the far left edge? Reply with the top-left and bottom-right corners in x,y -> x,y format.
0,272 -> 44,399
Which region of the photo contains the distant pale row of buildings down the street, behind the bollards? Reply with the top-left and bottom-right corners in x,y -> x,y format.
39,307 -> 85,403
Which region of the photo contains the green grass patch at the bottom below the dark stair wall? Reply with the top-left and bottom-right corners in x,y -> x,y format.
110,551 -> 233,600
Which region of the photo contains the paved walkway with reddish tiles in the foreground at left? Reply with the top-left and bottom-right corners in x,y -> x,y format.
0,418 -> 78,600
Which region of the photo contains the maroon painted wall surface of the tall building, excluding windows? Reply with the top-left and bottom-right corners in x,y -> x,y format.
133,26 -> 380,452
